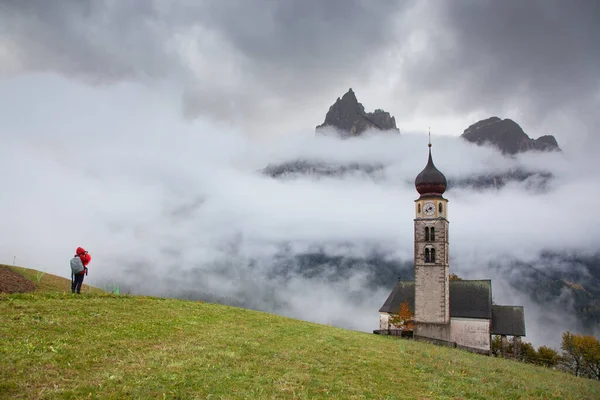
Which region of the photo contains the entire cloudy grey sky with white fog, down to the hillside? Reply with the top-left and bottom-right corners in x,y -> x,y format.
0,0 -> 600,345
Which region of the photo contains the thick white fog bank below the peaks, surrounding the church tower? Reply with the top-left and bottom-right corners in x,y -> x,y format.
0,124 -> 600,346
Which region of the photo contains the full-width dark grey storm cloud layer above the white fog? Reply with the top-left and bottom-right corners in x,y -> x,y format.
0,0 -> 600,137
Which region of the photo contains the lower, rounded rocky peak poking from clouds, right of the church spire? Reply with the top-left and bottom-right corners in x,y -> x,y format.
461,117 -> 561,154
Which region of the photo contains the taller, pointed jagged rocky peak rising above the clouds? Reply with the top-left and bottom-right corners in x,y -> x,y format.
316,88 -> 400,136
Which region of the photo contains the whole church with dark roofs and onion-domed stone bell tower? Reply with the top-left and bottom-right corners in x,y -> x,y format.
374,143 -> 525,355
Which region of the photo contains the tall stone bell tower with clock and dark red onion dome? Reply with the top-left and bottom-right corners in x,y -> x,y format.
414,140 -> 450,341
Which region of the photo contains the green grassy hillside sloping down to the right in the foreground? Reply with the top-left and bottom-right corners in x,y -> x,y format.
0,270 -> 600,399
